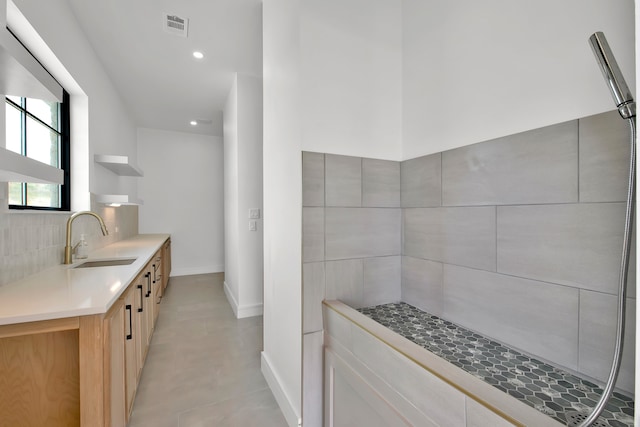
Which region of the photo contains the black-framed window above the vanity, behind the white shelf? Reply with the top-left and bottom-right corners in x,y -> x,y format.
6,92 -> 71,211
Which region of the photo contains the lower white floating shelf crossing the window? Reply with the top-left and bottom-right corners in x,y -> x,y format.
0,147 -> 64,184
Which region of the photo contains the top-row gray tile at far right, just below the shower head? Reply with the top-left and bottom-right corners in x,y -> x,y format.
579,110 -> 631,202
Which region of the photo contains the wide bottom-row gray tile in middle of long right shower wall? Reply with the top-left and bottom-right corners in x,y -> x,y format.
443,265 -> 579,369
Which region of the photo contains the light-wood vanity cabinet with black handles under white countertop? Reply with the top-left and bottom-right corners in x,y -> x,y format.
0,236 -> 166,427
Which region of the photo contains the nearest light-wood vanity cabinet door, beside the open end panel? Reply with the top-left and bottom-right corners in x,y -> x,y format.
105,300 -> 127,427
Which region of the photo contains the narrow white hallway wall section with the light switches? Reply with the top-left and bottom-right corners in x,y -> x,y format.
224,74 -> 263,318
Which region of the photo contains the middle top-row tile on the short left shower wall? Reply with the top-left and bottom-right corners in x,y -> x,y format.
324,154 -> 362,207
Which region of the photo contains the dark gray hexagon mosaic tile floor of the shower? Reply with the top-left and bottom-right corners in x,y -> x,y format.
358,303 -> 634,427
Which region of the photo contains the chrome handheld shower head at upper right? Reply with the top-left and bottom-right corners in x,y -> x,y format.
589,31 -> 636,119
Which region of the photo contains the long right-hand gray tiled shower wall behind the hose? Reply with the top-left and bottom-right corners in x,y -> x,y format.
401,112 -> 636,391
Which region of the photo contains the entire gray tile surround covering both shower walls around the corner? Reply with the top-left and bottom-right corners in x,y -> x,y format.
302,112 -> 636,404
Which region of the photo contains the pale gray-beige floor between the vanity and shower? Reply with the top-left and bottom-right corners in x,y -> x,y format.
129,273 -> 287,427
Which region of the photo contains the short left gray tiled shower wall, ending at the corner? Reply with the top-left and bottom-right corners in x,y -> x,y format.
302,152 -> 402,427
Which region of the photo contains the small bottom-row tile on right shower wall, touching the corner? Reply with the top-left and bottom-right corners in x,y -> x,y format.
402,256 -> 443,316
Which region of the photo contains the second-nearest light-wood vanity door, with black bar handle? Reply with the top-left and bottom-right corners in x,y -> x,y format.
124,286 -> 138,421
